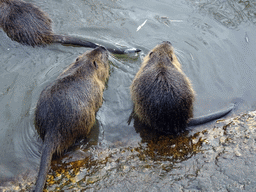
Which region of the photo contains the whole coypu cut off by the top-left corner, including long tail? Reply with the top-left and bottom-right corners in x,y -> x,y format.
0,0 -> 140,54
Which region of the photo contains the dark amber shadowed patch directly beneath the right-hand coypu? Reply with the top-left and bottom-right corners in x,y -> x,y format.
131,120 -> 203,164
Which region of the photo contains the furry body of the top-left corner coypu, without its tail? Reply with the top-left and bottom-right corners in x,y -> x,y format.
0,0 -> 53,47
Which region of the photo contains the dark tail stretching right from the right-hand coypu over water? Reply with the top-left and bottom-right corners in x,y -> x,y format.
187,104 -> 235,127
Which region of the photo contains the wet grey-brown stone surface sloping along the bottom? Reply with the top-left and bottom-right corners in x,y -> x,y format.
2,112 -> 256,191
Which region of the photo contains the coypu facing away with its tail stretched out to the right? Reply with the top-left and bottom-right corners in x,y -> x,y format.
128,42 -> 234,133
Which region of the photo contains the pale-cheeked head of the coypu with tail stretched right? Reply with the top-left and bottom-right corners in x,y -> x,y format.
142,41 -> 181,71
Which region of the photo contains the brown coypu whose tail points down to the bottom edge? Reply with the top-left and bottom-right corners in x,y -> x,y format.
34,47 -> 109,191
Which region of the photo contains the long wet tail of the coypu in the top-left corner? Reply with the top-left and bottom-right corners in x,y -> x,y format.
53,35 -> 141,54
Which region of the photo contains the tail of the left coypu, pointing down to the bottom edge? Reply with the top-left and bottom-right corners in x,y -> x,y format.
35,135 -> 56,192
